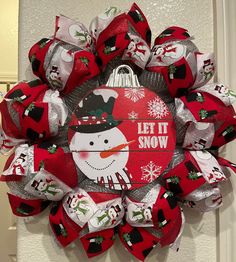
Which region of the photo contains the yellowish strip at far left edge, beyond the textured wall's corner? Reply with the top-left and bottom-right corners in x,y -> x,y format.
0,0 -> 19,262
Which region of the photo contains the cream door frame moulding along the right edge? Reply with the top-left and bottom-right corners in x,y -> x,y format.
213,0 -> 236,262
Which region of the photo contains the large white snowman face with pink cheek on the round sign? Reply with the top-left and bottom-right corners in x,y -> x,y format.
70,127 -> 129,180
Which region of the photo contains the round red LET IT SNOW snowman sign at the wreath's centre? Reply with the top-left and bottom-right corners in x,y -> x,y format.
68,86 -> 175,190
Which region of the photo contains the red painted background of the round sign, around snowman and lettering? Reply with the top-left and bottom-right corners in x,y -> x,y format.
68,86 -> 176,189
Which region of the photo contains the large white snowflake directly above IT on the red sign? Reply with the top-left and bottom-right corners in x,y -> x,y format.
148,97 -> 169,119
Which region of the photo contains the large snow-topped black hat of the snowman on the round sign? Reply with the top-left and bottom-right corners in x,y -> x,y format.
70,88 -> 121,133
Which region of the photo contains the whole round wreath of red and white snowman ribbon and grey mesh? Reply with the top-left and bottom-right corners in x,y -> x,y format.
0,4 -> 236,260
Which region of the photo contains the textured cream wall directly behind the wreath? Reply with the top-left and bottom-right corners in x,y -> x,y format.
17,0 -> 217,262
